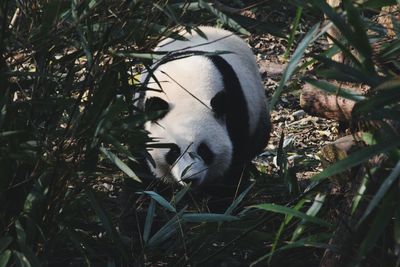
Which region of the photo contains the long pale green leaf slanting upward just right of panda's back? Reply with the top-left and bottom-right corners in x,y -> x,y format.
269,23 -> 319,110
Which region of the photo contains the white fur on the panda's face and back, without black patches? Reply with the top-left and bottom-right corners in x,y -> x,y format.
145,27 -> 266,186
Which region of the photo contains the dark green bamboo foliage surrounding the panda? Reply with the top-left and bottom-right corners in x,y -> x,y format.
0,0 -> 400,266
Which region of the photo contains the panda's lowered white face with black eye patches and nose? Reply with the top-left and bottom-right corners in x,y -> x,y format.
144,57 -> 233,185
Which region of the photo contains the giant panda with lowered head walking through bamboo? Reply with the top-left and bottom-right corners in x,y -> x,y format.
142,26 -> 271,186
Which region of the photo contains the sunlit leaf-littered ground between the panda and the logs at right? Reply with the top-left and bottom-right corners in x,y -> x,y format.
249,28 -> 338,180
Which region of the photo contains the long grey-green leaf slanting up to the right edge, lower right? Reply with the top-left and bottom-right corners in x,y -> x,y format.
358,161 -> 400,225
